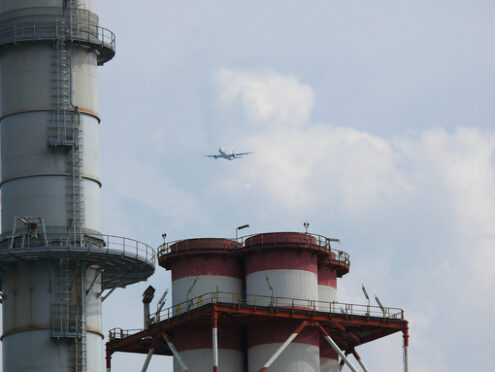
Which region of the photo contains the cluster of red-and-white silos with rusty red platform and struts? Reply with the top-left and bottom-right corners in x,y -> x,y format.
106,232 -> 409,372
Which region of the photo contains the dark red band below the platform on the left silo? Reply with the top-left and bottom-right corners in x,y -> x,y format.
172,324 -> 242,351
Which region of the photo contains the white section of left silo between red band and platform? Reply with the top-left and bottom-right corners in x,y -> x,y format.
172,275 -> 243,305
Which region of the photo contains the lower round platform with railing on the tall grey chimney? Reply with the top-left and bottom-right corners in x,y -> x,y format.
0,233 -> 155,289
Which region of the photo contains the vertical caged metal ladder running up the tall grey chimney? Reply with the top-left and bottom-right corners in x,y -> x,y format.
47,0 -> 87,372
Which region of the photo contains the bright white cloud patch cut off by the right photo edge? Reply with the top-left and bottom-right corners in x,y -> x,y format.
406,128 -> 495,290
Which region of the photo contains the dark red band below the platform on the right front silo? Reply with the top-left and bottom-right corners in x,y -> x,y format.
248,321 -> 320,347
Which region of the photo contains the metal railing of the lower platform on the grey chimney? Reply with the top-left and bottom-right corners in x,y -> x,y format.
0,232 -> 156,266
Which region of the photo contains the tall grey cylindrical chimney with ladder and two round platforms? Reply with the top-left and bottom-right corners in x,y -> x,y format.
0,0 -> 155,372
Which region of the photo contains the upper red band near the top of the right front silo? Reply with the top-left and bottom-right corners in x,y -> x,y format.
245,250 -> 318,275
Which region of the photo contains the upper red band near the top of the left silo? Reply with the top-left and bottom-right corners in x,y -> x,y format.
171,255 -> 243,280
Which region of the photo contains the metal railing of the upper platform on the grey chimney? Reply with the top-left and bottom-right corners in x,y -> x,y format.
0,21 -> 115,50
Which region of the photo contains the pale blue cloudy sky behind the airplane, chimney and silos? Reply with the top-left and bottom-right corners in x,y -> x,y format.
92,0 -> 495,372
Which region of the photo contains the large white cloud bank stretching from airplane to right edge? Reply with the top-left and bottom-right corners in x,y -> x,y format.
219,69 -> 495,286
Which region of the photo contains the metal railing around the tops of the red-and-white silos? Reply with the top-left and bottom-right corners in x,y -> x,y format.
157,233 -> 351,266
